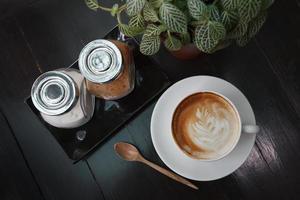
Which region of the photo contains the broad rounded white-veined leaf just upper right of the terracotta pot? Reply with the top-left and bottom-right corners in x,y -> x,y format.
195,21 -> 226,53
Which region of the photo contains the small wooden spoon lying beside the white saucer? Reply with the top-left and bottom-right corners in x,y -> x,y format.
114,142 -> 198,190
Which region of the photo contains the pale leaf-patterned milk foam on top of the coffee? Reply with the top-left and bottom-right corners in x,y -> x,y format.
186,100 -> 236,156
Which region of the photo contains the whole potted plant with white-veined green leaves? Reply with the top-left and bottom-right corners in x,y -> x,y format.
85,0 -> 273,58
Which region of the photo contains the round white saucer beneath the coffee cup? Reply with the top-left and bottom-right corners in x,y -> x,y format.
151,76 -> 256,181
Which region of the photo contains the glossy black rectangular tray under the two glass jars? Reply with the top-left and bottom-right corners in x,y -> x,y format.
26,28 -> 170,163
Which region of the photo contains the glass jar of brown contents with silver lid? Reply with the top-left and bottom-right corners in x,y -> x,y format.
78,39 -> 135,100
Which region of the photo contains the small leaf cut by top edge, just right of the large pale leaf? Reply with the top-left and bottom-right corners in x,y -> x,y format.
187,0 -> 207,20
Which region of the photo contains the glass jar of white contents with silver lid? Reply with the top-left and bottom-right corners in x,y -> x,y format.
31,69 -> 95,128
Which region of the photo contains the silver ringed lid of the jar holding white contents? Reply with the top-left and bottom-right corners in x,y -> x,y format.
31,71 -> 76,115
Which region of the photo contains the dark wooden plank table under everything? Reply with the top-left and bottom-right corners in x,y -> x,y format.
0,0 -> 300,200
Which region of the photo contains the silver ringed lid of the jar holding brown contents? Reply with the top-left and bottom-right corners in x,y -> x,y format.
78,39 -> 122,83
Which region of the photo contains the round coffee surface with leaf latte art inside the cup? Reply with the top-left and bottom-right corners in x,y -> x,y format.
172,92 -> 239,159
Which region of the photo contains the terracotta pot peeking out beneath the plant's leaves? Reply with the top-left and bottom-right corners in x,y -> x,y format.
170,43 -> 204,60
